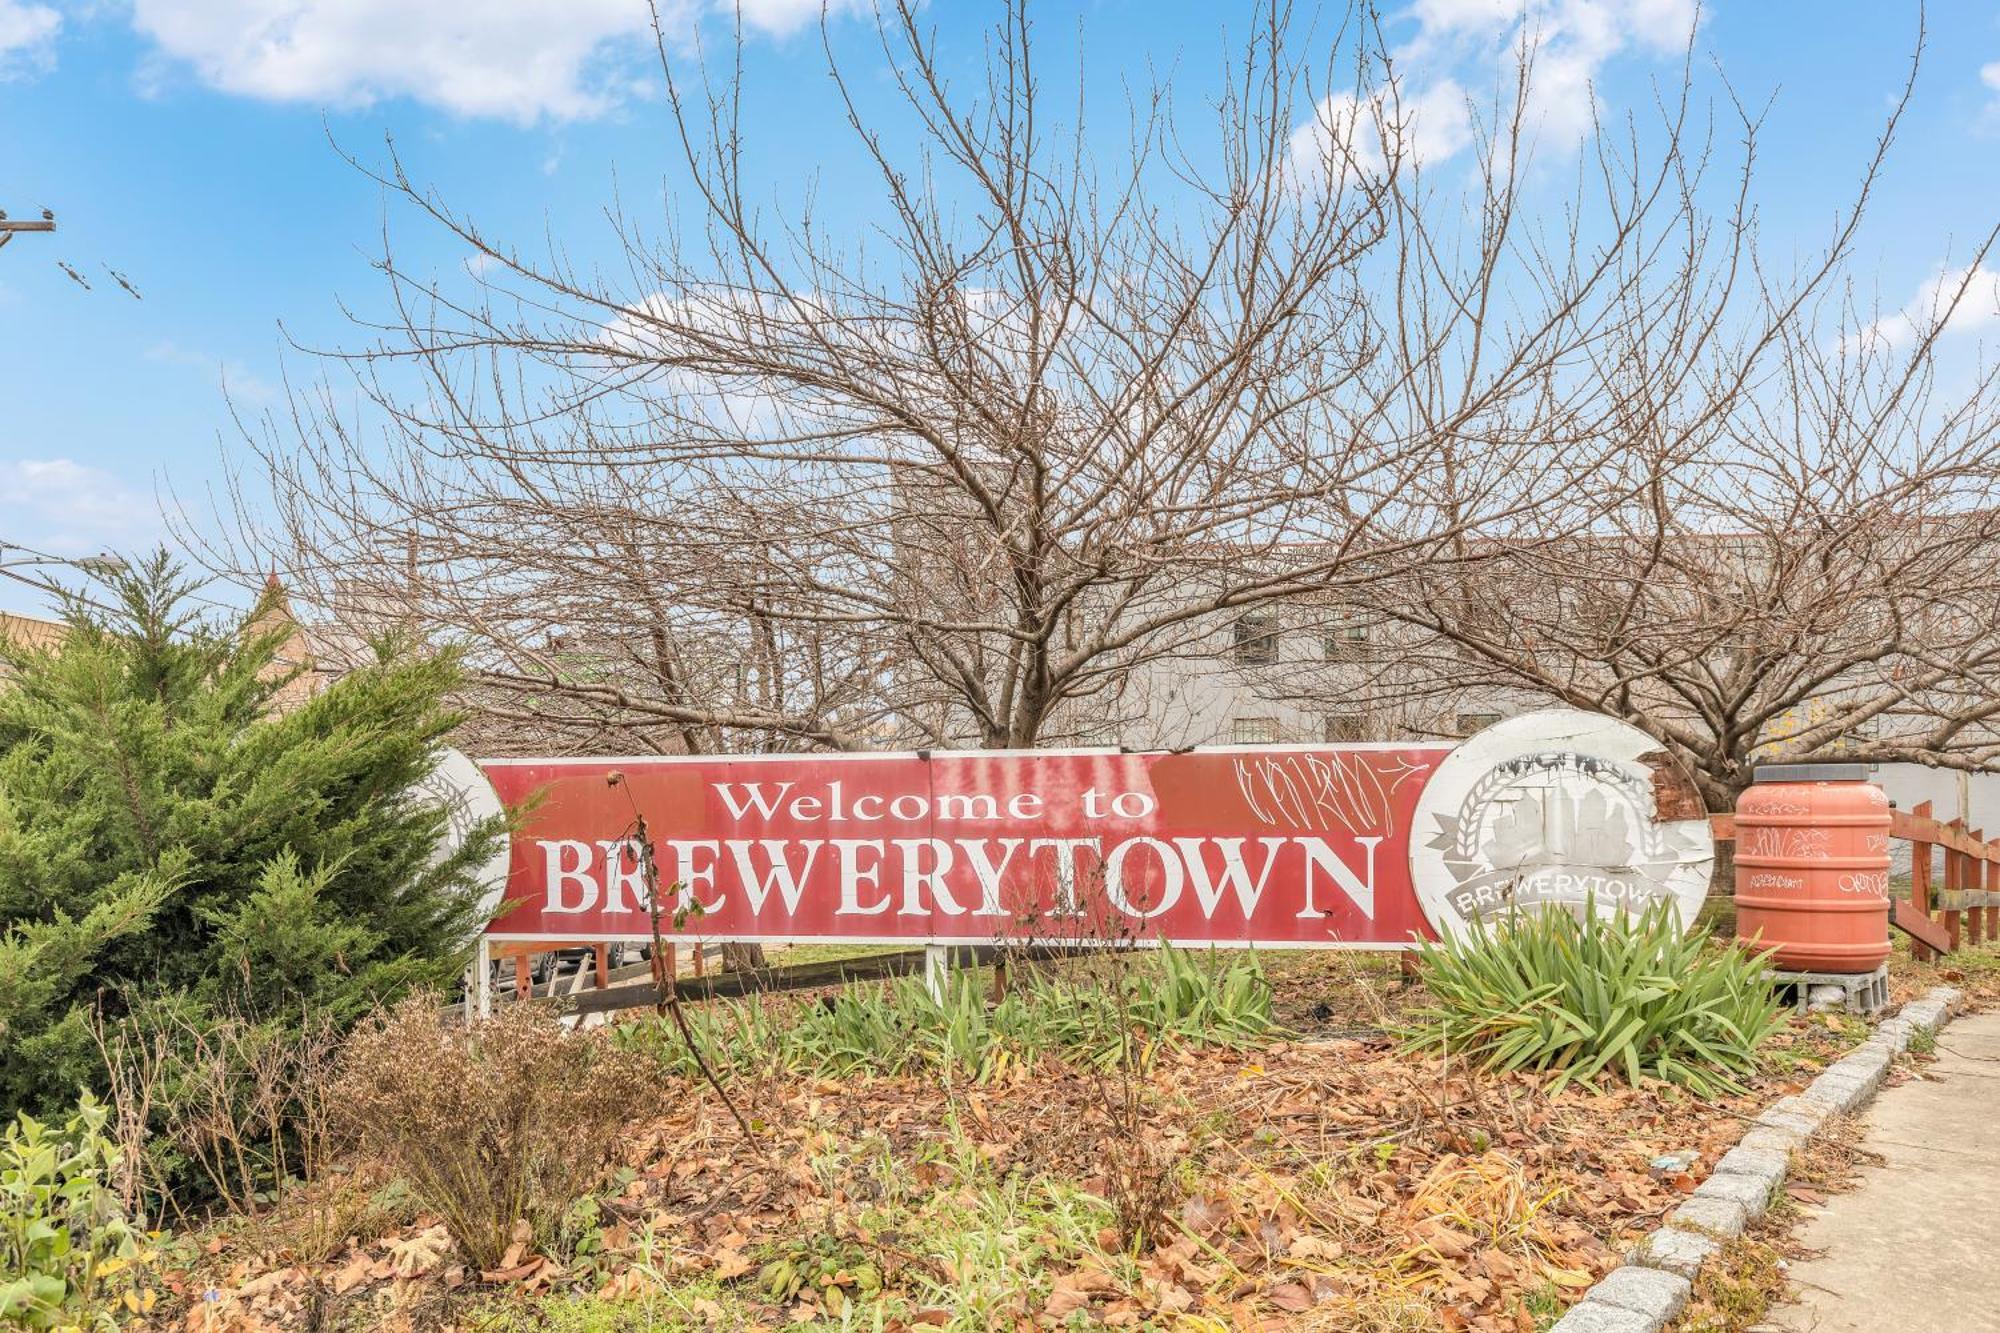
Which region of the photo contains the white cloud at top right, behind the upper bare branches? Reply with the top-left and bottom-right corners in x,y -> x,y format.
1292,0 -> 1700,180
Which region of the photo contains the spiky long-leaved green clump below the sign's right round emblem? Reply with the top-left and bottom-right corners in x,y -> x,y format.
1404,903 -> 1780,1095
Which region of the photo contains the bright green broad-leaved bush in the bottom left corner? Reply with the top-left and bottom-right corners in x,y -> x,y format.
0,1097 -> 152,1329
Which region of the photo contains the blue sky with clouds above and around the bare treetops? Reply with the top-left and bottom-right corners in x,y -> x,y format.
0,0 -> 2000,608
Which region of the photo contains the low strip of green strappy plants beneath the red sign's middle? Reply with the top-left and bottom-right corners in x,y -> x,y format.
616,947 -> 1276,1079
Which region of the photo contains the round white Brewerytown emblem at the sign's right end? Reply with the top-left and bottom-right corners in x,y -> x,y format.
1410,709 -> 1716,935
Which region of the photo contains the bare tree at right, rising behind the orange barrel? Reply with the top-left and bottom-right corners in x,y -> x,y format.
1344,39 -> 2000,811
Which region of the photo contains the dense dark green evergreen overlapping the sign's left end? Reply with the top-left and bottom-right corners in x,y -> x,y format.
0,552 -> 500,1119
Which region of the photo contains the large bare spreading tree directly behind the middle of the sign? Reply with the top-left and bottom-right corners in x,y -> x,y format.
212,0 -> 1784,751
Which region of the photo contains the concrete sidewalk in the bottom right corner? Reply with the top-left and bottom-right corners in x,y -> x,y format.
1762,1013 -> 2000,1333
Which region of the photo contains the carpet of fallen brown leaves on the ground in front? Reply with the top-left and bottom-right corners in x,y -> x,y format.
152,1012 -> 1856,1333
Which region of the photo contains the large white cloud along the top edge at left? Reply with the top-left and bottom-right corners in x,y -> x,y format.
125,0 -> 864,124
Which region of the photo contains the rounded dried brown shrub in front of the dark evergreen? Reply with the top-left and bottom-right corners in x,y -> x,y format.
334,995 -> 650,1269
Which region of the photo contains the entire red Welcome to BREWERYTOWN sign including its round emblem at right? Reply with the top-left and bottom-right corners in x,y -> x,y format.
464,709 -> 1714,949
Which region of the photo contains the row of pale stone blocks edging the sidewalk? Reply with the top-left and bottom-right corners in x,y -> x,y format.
1550,987 -> 1964,1333
